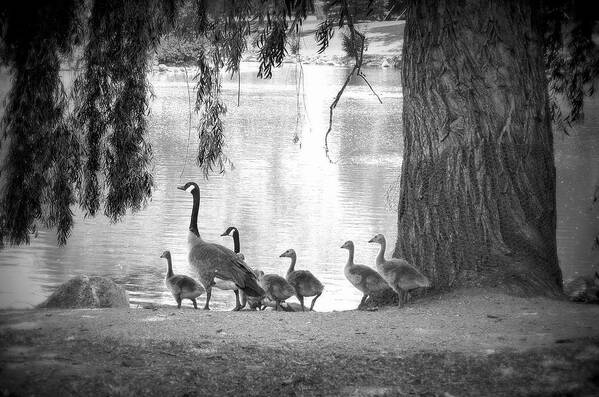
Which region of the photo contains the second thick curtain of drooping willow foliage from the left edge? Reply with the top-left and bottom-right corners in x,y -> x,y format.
74,0 -> 175,221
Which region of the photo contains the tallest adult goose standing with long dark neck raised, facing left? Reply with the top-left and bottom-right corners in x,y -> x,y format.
177,182 -> 264,310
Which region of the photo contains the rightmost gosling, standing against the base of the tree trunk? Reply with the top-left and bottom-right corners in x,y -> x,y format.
368,234 -> 431,307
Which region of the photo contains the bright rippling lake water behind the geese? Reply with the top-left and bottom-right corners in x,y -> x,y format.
0,64 -> 599,311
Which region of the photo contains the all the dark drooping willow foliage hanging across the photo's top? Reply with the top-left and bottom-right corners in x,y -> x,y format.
0,0 -> 599,245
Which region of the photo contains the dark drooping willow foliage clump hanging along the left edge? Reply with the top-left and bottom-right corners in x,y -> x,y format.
0,0 -> 84,244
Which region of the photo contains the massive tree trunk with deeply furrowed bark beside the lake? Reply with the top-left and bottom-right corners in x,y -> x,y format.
394,0 -> 561,295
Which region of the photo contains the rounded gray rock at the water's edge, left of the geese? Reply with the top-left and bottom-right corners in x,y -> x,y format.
38,275 -> 129,309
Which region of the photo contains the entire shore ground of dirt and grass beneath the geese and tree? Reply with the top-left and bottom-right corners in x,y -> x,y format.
0,290 -> 599,397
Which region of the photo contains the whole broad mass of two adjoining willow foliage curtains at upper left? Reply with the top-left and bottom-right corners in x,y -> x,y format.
0,0 -> 175,245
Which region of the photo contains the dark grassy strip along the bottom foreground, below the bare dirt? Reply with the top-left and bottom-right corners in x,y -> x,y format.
0,332 -> 599,396
